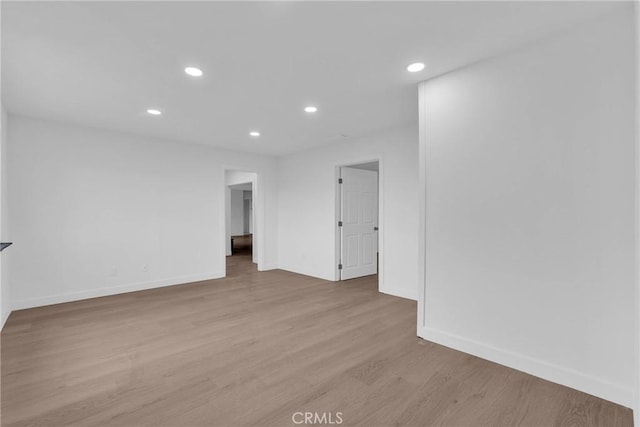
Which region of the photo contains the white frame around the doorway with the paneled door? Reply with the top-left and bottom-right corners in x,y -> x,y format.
334,159 -> 386,291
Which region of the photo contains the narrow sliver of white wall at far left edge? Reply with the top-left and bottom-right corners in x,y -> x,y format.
0,106 -> 13,330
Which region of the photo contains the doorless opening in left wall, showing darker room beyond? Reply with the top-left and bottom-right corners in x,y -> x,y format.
225,169 -> 259,276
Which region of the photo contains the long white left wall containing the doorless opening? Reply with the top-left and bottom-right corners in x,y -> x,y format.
8,115 -> 277,309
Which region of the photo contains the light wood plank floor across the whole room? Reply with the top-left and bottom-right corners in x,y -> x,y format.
2,249 -> 632,427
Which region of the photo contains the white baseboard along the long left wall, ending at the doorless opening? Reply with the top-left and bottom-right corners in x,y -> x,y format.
11,272 -> 224,310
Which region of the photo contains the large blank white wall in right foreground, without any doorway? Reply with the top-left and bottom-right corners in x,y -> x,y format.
418,9 -> 638,410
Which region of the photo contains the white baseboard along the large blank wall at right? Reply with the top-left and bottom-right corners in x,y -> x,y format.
418,325 -> 637,409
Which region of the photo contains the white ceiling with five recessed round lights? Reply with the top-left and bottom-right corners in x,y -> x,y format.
2,1 -> 618,155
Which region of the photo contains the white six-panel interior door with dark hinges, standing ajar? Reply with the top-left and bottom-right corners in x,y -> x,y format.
340,167 -> 378,280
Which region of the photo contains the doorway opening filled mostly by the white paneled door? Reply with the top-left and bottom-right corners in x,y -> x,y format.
336,160 -> 383,289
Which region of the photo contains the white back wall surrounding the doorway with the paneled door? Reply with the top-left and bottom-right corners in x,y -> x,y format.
278,129 -> 418,299
